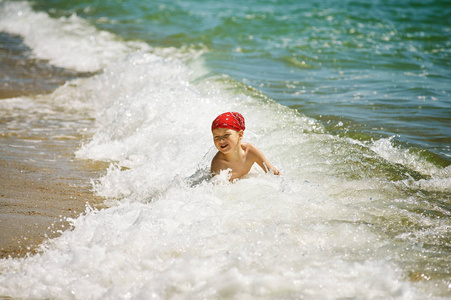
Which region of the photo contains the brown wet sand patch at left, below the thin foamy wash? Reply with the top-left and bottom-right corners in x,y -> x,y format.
0,125 -> 106,258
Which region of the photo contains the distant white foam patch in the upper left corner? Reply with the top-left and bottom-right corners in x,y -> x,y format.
0,1 -> 150,72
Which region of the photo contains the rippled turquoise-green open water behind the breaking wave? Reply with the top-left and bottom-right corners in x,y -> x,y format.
32,0 -> 451,165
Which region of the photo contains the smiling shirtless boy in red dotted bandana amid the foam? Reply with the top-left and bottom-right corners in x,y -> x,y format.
211,112 -> 279,180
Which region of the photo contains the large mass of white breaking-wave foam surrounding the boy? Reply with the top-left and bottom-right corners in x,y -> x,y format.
0,3 -> 447,299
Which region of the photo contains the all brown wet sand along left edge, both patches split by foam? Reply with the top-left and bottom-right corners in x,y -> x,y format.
0,32 -> 105,258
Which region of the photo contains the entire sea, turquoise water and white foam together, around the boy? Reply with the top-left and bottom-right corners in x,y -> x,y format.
0,0 -> 451,299
